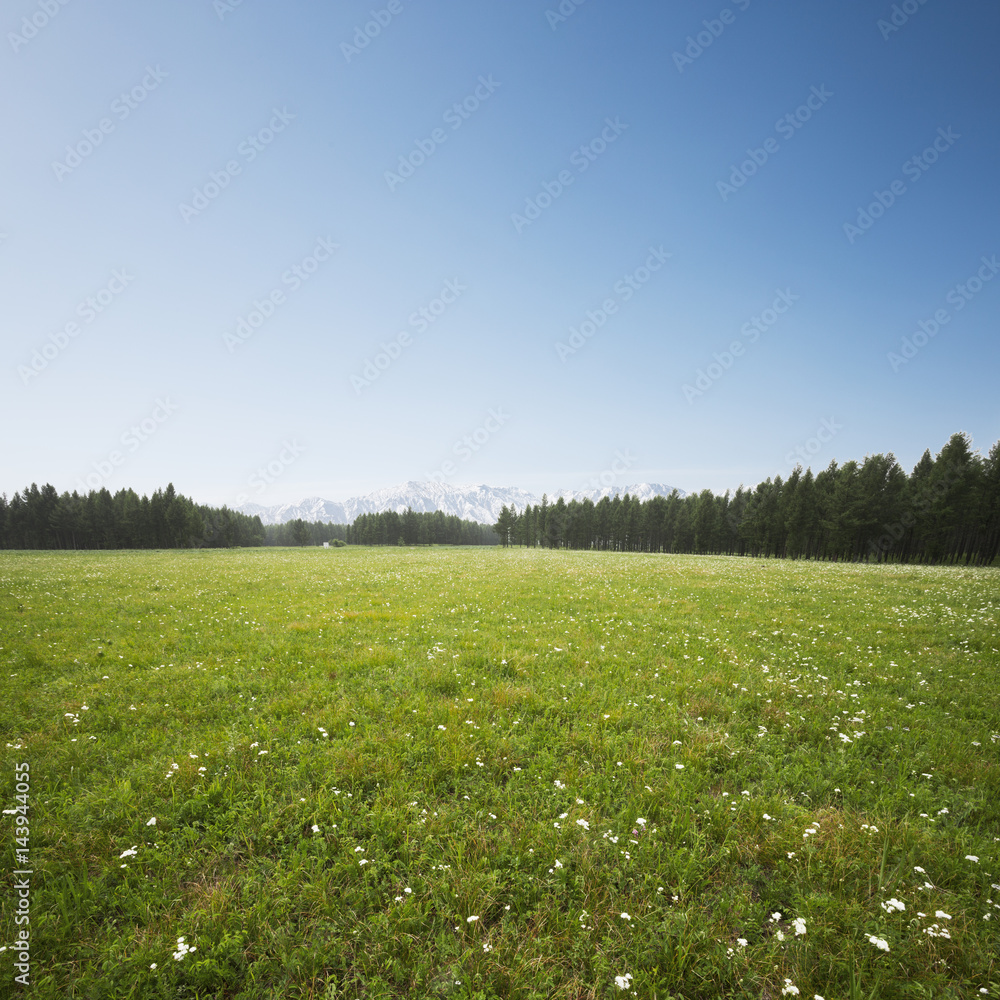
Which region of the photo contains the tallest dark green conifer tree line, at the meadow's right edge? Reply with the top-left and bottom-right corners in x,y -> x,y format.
493,434 -> 1000,565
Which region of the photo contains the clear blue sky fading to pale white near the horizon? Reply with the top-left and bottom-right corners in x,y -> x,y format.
0,0 -> 1000,506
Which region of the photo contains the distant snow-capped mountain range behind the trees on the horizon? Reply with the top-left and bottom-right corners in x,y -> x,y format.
236,482 -> 684,524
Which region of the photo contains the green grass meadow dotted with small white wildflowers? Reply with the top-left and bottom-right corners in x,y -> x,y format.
0,548 -> 1000,1000
